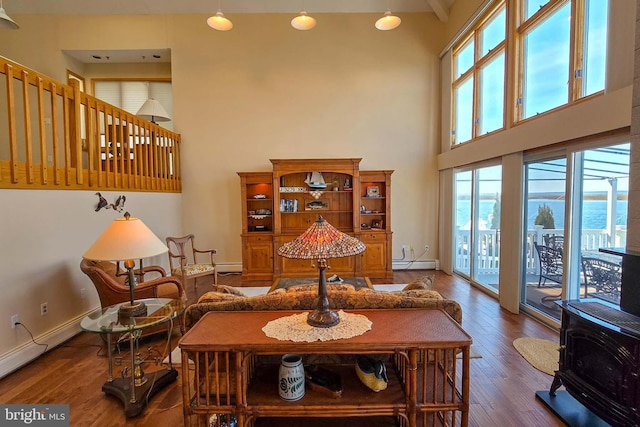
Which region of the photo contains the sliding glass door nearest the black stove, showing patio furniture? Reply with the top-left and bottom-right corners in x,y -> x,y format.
521,142 -> 630,319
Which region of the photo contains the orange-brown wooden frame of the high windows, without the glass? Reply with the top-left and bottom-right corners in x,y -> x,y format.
449,0 -> 612,148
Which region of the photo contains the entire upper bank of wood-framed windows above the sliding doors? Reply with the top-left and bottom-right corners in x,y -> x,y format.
451,0 -> 609,145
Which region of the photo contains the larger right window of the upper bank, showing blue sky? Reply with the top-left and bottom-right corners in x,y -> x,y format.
516,0 -> 608,120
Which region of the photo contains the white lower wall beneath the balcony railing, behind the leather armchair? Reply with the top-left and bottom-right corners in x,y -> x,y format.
0,190 -> 182,376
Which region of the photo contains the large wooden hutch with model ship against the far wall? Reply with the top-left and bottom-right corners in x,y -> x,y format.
238,158 -> 393,281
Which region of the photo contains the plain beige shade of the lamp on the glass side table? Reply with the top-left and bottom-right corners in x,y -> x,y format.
83,216 -> 168,261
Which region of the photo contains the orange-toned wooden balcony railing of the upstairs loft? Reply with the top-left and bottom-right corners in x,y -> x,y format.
0,56 -> 182,192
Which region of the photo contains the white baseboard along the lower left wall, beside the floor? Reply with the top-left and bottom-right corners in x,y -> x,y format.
0,310 -> 95,378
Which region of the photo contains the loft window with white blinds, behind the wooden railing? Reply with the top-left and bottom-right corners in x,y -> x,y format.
94,80 -> 173,130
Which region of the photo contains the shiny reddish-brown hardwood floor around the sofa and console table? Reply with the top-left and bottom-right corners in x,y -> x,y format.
0,270 -> 564,427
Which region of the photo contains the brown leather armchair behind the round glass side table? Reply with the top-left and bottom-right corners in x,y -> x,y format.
80,258 -> 187,332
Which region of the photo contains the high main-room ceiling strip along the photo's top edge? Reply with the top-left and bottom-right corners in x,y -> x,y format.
4,0 -> 455,15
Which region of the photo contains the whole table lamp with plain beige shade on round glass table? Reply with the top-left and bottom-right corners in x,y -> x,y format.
83,212 -> 168,317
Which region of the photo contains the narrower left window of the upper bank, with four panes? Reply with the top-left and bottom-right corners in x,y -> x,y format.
451,2 -> 506,144
